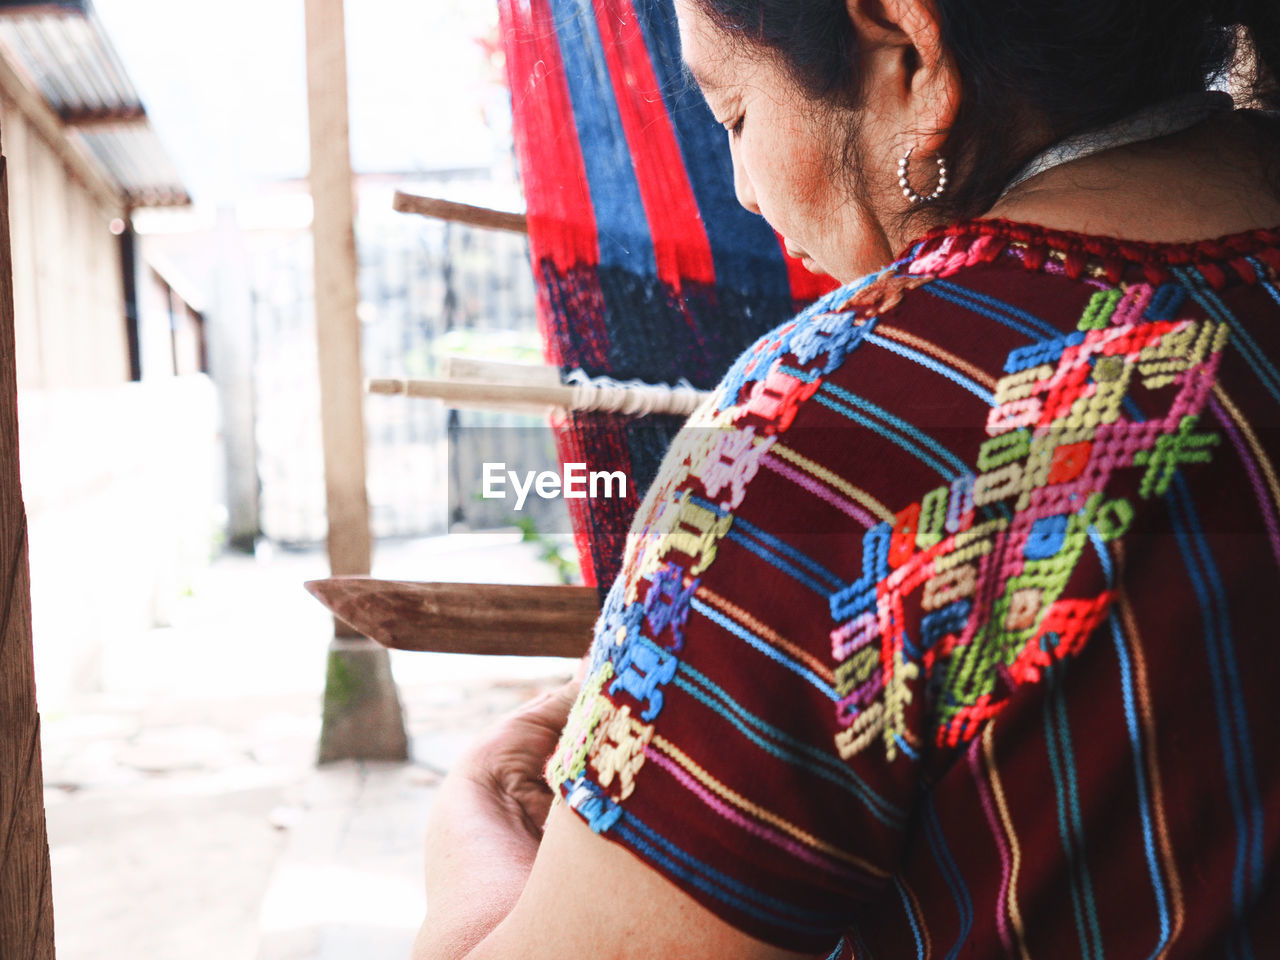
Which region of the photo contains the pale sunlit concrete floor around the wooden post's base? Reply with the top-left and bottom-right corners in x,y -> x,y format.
36,535 -> 585,960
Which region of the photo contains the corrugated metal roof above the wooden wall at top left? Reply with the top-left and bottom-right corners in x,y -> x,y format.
0,0 -> 191,206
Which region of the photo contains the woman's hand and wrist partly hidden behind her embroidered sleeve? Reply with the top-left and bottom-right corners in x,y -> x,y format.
413,681 -> 580,960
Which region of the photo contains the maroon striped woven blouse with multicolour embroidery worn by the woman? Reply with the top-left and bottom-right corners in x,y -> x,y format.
548,221 -> 1280,960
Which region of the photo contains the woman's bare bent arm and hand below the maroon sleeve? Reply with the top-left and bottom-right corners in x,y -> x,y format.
413,687 -> 806,960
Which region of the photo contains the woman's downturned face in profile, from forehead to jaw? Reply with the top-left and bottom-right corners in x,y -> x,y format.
676,0 -> 901,282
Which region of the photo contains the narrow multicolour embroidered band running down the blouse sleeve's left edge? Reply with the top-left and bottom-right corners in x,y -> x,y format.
547,271 -> 920,808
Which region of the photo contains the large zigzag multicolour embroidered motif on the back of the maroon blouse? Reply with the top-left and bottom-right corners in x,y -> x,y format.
831,291 -> 1228,759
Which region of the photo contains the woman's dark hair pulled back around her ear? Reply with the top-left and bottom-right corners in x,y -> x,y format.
696,0 -> 1280,227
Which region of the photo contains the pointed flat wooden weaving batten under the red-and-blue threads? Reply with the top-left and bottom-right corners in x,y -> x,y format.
306,577 -> 600,657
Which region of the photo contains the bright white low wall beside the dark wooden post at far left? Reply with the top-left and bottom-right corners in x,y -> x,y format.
18,375 -> 221,709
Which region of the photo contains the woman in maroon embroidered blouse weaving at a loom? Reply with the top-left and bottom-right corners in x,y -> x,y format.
417,0 -> 1280,957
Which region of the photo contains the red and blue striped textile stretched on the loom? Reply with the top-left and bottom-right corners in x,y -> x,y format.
498,0 -> 832,584
